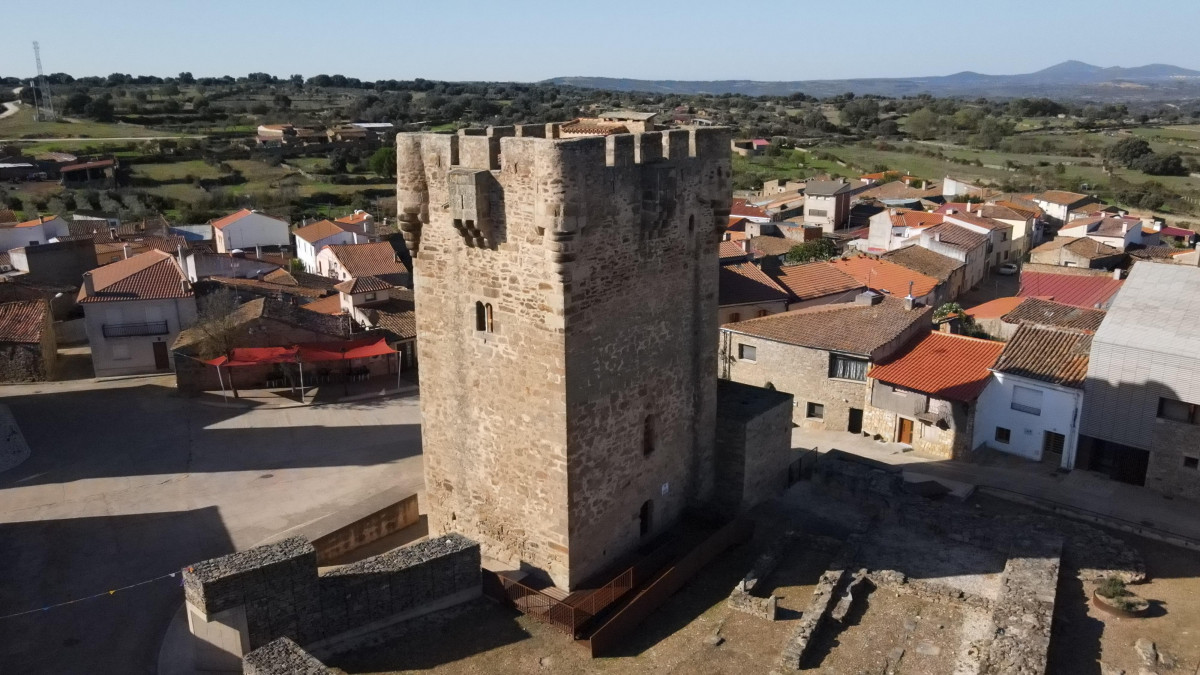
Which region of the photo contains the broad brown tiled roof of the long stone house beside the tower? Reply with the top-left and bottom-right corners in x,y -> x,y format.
722,298 -> 934,357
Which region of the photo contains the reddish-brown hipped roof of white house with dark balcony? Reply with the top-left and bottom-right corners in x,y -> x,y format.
79,251 -> 192,303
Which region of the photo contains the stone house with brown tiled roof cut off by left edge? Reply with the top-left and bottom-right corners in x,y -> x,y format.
0,299 -> 58,382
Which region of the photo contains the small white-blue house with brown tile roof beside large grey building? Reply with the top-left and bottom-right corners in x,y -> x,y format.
971,323 -> 1092,470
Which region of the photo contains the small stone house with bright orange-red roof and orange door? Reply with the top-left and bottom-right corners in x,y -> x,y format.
863,333 -> 1004,459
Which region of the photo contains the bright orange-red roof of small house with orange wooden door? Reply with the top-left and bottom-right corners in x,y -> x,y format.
868,333 -> 1004,402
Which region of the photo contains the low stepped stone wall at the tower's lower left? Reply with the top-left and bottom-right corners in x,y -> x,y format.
184,534 -> 481,657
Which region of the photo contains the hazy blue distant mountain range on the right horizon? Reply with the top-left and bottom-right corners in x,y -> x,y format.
546,61 -> 1200,98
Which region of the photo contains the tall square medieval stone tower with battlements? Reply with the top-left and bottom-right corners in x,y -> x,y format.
396,125 -> 731,590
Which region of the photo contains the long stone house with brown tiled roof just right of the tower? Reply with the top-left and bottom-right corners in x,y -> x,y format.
719,292 -> 934,434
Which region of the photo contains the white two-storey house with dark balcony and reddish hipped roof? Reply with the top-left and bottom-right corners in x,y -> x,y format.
78,251 -> 196,377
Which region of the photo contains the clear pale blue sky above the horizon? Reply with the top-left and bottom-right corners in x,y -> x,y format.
0,0 -> 1200,82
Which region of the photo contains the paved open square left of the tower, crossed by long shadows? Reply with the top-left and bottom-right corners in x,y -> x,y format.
0,377 -> 424,675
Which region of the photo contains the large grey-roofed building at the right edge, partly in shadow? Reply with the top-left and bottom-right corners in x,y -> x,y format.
1075,264 -> 1200,498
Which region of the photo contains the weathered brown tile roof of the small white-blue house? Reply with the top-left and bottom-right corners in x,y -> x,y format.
995,323 -> 1092,389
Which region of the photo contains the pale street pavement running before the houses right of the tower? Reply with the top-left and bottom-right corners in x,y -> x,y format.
792,429 -> 1200,542
